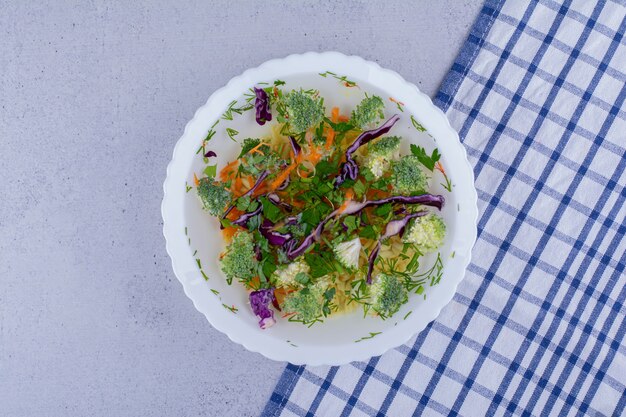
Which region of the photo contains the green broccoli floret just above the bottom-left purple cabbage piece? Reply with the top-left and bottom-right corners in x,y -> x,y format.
221,231 -> 257,284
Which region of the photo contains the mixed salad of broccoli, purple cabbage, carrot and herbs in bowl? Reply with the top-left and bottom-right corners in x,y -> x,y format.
196,81 -> 447,328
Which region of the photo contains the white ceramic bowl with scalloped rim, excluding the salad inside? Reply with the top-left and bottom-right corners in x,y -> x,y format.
161,52 -> 478,365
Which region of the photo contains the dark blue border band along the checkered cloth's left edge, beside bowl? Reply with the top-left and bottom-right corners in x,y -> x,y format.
260,0 -> 504,417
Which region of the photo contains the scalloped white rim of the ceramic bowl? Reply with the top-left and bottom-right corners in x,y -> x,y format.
161,52 -> 478,365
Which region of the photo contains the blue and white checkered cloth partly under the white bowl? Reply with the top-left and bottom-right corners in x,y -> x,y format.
263,0 -> 626,417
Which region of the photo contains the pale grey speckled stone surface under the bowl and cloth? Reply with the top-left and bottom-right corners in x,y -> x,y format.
0,0 -> 481,416
